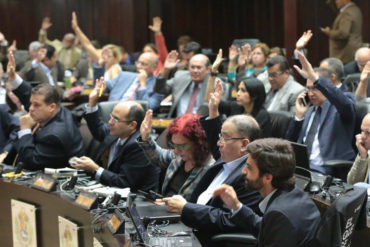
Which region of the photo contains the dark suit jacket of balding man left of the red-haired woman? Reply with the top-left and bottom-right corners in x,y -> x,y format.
85,111 -> 159,191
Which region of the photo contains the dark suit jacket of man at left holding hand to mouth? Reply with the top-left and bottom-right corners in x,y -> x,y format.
13,82 -> 85,170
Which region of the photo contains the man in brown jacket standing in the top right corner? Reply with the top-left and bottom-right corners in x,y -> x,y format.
321,0 -> 362,64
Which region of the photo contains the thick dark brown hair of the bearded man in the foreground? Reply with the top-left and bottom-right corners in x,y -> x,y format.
247,138 -> 296,189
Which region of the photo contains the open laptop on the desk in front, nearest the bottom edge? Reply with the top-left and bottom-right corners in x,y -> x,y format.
126,196 -> 200,247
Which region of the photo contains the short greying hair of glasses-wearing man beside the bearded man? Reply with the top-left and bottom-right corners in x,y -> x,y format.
225,114 -> 261,142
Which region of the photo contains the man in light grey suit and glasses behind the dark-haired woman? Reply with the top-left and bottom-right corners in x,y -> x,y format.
265,55 -> 304,113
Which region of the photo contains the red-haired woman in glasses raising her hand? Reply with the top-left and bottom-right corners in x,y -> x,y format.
139,110 -> 214,200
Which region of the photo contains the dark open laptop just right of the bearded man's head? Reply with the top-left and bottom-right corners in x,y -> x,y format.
290,142 -> 311,190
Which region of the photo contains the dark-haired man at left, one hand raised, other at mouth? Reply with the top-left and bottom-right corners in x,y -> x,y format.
7,53 -> 84,170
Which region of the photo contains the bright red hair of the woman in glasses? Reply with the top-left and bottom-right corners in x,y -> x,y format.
167,113 -> 211,166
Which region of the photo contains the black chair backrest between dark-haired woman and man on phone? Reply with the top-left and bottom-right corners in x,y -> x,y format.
269,111 -> 292,138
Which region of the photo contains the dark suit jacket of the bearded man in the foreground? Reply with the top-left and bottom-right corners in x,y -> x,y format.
230,188 -> 320,247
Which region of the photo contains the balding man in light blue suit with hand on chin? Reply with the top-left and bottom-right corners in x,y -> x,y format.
94,52 -> 163,109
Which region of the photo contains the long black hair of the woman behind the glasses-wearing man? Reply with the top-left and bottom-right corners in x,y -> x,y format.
238,76 -> 266,115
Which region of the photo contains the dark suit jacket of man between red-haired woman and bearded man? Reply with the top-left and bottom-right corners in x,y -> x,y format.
181,118 -> 262,237
